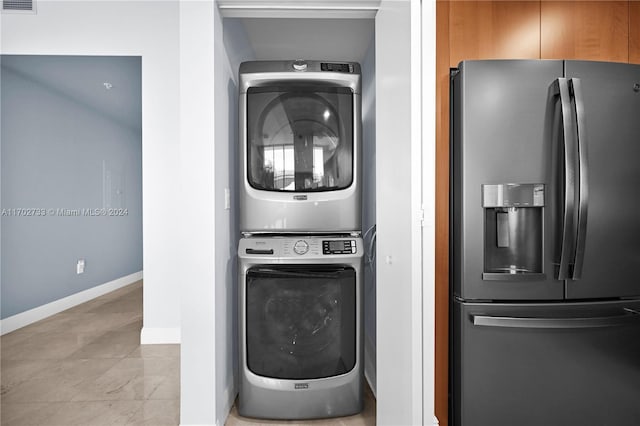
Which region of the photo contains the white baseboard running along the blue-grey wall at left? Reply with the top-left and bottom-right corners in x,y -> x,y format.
0,271 -> 142,335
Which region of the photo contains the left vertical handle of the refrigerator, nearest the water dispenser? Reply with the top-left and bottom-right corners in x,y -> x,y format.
549,78 -> 577,280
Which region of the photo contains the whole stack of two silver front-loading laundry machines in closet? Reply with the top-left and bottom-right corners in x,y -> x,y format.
238,60 -> 364,419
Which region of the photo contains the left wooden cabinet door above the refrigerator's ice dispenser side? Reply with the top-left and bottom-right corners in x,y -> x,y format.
449,1 -> 540,67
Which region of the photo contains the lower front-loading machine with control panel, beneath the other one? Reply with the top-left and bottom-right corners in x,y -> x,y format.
238,236 -> 364,419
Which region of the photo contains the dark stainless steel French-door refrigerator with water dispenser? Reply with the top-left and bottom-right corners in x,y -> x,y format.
450,60 -> 640,426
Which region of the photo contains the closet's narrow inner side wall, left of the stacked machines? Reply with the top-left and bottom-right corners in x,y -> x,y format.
214,9 -> 254,425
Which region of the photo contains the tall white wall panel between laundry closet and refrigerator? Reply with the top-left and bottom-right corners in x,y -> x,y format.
376,0 -> 424,425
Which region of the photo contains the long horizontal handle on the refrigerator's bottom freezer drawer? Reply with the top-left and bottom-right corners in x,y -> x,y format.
471,308 -> 640,329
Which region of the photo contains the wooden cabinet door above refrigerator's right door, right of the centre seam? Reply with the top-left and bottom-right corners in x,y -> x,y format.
540,0 -> 629,62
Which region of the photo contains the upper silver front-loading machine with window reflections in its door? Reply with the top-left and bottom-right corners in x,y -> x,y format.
239,61 -> 362,233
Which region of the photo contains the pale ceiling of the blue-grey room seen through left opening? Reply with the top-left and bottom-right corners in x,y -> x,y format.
1,55 -> 142,129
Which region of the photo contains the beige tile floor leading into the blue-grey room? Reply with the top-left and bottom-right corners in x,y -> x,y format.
0,281 -> 180,426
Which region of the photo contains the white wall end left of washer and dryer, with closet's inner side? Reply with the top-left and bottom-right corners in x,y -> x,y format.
180,2 -> 253,425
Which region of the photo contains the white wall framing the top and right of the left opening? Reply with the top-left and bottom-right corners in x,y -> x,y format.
0,0 -> 184,343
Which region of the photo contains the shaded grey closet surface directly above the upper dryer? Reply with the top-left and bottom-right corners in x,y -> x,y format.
239,18 -> 375,61
